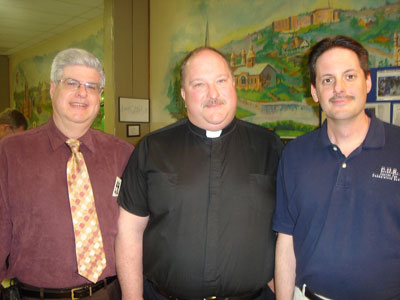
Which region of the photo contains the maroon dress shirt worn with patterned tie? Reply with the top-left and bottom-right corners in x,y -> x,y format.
0,119 -> 133,288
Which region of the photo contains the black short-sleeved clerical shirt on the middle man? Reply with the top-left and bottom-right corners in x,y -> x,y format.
118,119 -> 282,298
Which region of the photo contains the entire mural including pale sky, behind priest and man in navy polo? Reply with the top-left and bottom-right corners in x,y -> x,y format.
151,0 -> 400,138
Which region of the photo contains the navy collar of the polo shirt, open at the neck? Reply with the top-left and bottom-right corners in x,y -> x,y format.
318,109 -> 385,149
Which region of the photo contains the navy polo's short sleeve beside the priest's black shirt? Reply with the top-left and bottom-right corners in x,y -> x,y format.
272,151 -> 295,235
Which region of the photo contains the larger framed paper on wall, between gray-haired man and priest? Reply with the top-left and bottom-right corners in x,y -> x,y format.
118,97 -> 150,123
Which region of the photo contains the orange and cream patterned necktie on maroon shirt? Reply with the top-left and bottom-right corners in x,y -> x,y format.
66,139 -> 106,282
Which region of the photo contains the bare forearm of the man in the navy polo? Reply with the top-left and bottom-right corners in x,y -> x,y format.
275,233 -> 296,300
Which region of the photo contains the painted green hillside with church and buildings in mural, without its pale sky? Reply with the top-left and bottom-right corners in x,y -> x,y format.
165,1 -> 400,138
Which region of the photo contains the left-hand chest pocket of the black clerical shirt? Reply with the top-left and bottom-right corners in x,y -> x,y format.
147,172 -> 178,216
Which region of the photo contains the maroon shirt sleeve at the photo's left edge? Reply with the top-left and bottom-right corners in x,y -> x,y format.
0,143 -> 12,282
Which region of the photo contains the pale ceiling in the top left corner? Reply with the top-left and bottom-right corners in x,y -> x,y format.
0,0 -> 104,55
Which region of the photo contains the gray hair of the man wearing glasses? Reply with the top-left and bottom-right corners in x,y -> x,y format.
50,48 -> 106,88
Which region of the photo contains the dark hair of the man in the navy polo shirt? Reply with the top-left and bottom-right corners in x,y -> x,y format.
308,35 -> 369,86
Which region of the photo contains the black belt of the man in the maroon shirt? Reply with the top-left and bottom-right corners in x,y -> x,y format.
18,276 -> 117,299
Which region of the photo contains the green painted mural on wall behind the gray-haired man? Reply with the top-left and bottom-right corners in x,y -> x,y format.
11,29 -> 104,130
